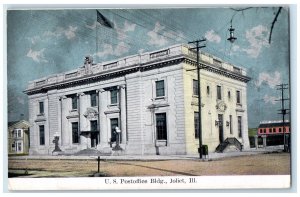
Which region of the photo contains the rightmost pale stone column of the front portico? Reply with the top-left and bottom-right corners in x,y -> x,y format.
119,85 -> 127,144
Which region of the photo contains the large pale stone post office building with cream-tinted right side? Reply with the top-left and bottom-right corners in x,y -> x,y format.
25,45 -> 250,155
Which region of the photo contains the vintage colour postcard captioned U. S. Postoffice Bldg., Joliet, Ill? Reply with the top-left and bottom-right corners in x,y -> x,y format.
6,6 -> 292,191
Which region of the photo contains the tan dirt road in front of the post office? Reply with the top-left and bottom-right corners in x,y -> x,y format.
8,153 -> 290,178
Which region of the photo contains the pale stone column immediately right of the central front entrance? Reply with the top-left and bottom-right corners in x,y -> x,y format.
99,89 -> 108,147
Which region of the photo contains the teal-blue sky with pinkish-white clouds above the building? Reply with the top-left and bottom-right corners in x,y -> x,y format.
7,7 -> 290,128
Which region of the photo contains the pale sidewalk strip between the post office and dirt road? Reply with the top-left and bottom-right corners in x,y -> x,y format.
8,146 -> 283,161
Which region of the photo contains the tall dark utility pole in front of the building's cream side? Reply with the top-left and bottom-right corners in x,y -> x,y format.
189,39 -> 206,159
